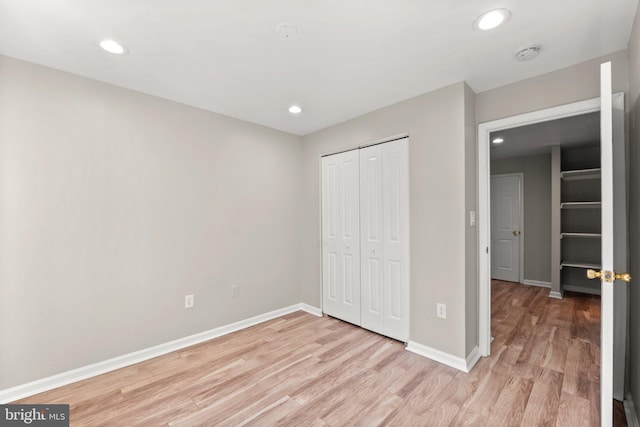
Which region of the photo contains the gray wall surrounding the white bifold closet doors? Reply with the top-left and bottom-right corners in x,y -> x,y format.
301,83 -> 477,357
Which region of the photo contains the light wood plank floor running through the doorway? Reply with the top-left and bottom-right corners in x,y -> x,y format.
17,281 -> 624,427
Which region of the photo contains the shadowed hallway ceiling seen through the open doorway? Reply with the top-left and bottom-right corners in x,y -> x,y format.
491,111 -> 600,159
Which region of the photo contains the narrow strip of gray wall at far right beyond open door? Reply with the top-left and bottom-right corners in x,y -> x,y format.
628,2 -> 640,418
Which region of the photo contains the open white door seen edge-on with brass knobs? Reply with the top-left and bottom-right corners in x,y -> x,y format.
589,62 -> 630,426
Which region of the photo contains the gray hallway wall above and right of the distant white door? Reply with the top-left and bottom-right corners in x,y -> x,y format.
491,154 -> 551,282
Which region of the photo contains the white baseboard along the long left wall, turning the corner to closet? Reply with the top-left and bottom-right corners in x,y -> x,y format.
0,303 -> 322,404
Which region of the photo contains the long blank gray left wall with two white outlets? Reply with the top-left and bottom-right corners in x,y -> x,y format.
0,57 -> 304,389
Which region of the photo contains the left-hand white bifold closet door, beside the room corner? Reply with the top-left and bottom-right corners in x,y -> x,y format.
322,150 -> 360,325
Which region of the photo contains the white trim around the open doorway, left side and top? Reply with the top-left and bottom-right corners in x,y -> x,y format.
478,98 -> 600,356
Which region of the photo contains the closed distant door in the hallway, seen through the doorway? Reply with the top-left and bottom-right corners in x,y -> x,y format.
491,175 -> 522,282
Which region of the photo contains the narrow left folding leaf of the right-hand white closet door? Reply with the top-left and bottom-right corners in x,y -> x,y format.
360,145 -> 384,333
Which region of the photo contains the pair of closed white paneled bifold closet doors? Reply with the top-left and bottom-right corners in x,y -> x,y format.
323,138 -> 409,341
